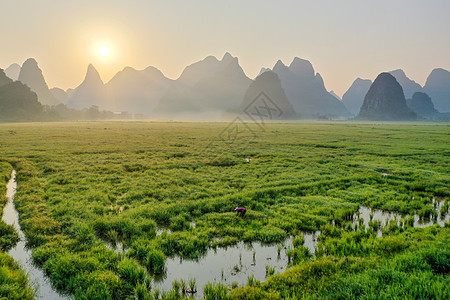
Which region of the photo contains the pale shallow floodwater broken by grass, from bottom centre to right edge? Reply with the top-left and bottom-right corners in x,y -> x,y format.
153,201 -> 450,299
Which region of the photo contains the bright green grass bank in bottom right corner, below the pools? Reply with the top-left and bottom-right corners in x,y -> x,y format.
230,226 -> 450,299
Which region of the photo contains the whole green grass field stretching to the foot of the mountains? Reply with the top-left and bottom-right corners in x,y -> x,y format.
0,122 -> 450,299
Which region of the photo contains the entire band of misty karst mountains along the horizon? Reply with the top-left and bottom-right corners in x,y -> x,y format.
0,53 -> 450,121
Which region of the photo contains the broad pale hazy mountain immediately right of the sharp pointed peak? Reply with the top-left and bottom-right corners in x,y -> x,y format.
106,67 -> 173,115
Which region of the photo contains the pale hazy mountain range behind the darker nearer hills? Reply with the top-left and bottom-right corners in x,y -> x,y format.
5,53 -> 450,120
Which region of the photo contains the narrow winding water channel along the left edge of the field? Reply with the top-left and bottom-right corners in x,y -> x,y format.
2,171 -> 69,300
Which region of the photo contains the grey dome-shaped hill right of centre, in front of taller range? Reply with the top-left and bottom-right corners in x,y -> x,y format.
239,71 -> 297,121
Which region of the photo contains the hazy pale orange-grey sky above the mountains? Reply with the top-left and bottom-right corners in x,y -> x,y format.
0,0 -> 450,95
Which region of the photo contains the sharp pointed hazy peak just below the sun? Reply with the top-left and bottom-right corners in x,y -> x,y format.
67,64 -> 114,110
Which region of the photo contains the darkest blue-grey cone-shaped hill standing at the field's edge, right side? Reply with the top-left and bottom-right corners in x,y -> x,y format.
358,73 -> 417,121
